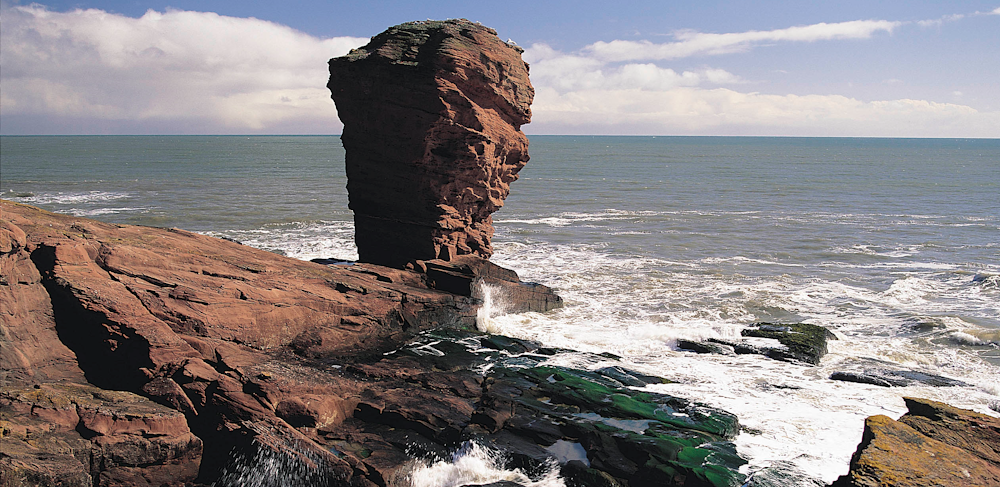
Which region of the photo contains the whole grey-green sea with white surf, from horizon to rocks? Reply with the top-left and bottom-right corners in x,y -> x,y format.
0,136 -> 1000,487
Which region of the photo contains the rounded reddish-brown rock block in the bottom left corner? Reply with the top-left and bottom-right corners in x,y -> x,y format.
0,382 -> 202,486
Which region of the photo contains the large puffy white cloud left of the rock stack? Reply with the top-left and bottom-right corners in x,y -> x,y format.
0,5 -> 368,133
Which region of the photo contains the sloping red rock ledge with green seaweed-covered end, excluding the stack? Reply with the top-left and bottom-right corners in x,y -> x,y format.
0,201 -> 743,487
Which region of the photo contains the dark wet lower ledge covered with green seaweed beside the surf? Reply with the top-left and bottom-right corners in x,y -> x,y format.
340,330 -> 745,487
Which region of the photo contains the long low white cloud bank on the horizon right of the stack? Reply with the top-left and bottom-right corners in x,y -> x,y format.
528,87 -> 1000,137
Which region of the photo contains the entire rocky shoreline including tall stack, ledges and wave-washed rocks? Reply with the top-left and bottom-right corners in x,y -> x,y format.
0,20 -> 1000,487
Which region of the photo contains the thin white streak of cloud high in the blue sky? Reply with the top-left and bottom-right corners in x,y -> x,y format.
583,20 -> 902,62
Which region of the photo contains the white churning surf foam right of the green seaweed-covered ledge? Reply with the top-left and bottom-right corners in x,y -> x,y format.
491,238 -> 997,482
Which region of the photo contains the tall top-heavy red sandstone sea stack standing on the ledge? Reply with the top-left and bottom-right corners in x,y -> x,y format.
328,20 -> 534,267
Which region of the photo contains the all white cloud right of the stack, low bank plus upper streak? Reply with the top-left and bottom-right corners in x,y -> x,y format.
524,15 -> 1000,137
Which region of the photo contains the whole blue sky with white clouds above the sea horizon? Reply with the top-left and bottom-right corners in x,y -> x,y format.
0,0 -> 1000,138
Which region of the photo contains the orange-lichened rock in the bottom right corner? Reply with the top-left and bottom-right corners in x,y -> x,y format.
834,398 -> 1000,487
